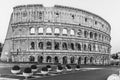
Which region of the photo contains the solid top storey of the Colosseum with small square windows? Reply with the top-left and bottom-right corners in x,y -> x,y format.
12,4 -> 111,35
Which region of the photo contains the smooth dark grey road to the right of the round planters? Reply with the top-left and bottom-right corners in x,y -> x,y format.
34,68 -> 118,80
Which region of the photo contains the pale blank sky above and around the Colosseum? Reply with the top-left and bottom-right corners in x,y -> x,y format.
0,0 -> 120,53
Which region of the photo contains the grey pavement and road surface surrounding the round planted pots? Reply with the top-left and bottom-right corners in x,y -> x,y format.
0,63 -> 120,80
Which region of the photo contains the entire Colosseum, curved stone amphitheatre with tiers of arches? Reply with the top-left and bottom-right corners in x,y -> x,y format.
1,4 -> 111,65
